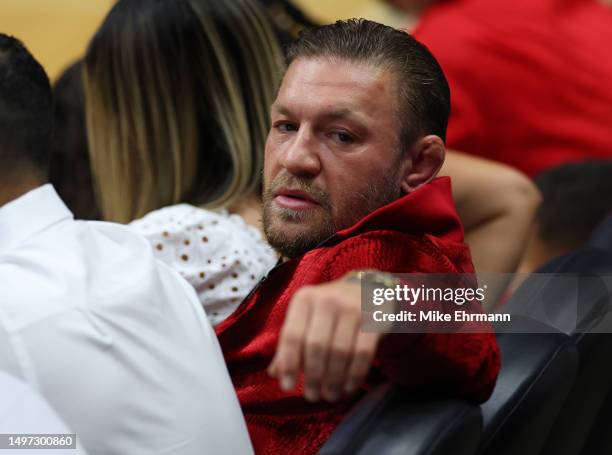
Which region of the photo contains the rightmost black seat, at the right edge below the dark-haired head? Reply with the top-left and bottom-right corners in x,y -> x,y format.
508,247 -> 612,455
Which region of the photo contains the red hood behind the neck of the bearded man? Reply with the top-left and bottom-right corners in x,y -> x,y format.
334,177 -> 463,243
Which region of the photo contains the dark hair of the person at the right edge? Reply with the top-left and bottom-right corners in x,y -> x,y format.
535,160 -> 612,248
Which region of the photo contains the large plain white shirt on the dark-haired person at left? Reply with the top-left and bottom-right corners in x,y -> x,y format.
0,185 -> 252,455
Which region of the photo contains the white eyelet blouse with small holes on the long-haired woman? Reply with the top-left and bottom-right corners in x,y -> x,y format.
130,204 -> 278,325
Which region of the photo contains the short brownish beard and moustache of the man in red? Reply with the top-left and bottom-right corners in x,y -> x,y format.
263,173 -> 401,259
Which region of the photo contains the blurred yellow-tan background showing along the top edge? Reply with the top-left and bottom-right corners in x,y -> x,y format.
0,0 -> 401,80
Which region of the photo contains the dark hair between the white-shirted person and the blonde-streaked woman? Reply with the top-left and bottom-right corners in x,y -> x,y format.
49,60 -> 101,220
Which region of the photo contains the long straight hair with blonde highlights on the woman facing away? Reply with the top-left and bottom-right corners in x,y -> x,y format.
84,0 -> 283,223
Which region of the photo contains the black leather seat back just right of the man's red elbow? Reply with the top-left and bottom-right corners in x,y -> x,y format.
478,316 -> 578,455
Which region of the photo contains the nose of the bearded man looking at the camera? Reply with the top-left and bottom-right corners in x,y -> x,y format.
281,127 -> 321,177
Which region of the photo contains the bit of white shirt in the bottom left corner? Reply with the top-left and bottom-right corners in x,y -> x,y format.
0,371 -> 86,455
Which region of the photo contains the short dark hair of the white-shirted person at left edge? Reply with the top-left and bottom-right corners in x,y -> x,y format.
0,33 -> 53,176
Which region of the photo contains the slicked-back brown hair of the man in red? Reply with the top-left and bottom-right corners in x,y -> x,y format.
287,19 -> 450,146
